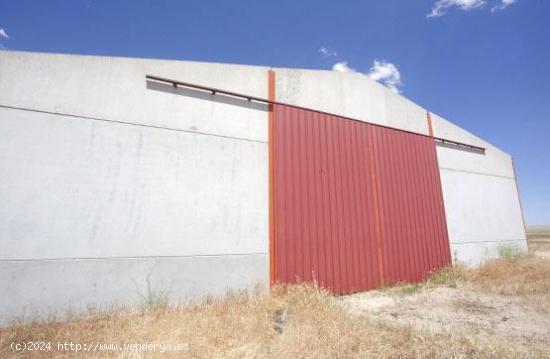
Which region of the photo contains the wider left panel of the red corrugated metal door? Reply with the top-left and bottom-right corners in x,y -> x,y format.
273,105 -> 379,293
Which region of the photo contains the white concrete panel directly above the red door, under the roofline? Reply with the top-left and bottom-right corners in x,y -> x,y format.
275,69 -> 389,124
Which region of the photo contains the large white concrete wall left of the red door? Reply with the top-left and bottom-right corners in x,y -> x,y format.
0,52 -> 269,322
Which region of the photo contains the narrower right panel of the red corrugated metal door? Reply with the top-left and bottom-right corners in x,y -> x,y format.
373,126 -> 450,285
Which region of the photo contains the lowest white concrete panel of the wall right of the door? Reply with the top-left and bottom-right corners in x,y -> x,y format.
451,240 -> 527,267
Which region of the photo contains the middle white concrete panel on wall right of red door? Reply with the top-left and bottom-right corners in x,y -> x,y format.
441,169 -> 526,243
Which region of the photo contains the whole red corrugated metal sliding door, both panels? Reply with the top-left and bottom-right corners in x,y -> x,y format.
272,105 -> 450,293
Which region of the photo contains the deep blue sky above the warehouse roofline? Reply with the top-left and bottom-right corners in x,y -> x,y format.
0,0 -> 550,224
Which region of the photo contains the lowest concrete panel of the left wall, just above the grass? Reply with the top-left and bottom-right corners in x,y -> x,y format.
0,254 -> 269,325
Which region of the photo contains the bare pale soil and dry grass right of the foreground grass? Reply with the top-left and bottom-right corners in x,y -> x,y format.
337,226 -> 550,357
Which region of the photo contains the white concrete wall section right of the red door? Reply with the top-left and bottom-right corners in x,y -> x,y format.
432,115 -> 527,265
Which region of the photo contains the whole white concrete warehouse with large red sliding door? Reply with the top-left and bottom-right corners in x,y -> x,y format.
0,51 -> 527,322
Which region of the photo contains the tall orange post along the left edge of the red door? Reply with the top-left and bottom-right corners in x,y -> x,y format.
267,70 -> 277,286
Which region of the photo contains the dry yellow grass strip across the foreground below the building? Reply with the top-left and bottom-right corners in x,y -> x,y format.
0,286 -> 528,358
